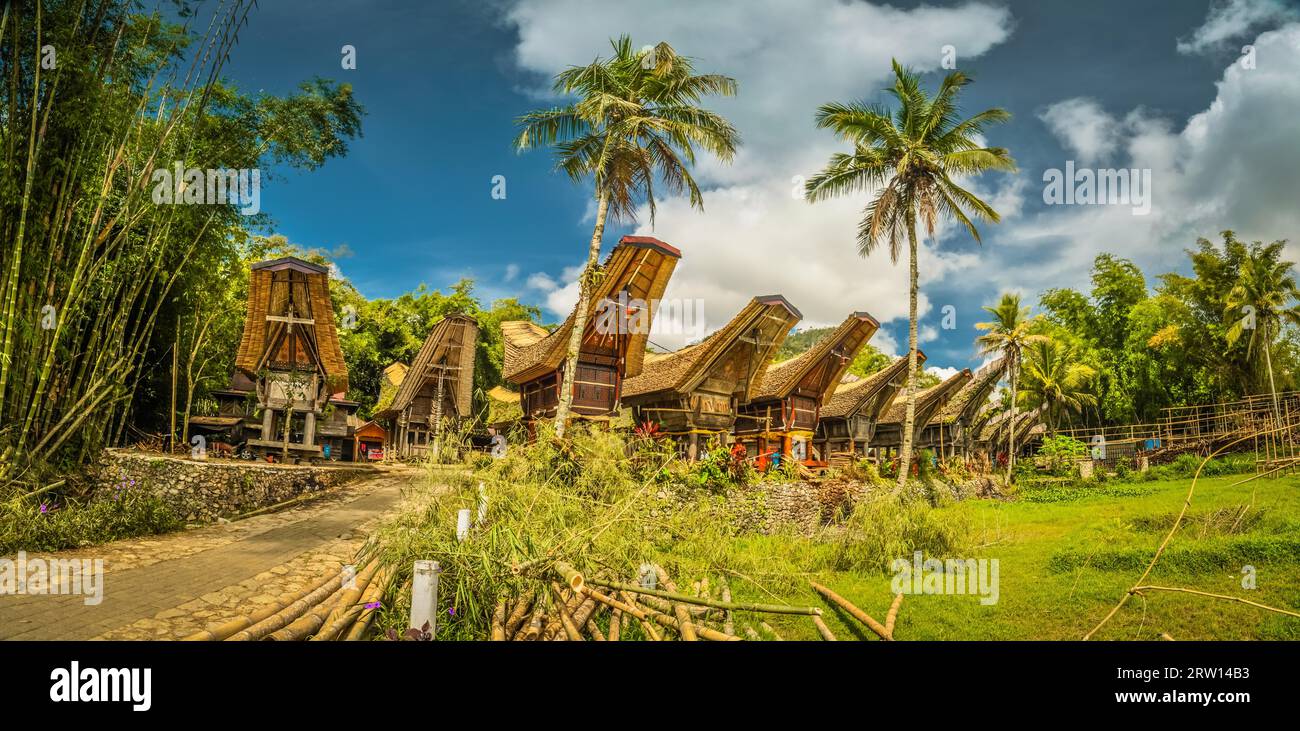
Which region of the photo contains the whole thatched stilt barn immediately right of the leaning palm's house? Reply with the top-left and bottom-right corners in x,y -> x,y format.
621,294 -> 802,460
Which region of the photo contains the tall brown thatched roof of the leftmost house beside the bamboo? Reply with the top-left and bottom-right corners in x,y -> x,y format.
235,256 -> 347,393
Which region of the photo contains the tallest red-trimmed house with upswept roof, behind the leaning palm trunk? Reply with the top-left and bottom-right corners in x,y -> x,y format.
501,235 -> 681,438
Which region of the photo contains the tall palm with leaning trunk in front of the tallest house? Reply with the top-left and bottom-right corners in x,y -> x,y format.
515,35 -> 740,437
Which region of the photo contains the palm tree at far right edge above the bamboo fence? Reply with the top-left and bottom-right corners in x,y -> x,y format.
1225,241 -> 1300,414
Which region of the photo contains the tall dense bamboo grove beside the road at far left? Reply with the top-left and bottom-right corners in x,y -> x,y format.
0,0 -> 363,490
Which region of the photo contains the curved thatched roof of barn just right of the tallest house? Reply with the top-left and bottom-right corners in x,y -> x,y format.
623,294 -> 802,402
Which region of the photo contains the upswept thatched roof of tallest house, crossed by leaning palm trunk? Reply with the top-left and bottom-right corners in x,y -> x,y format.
501,235 -> 681,384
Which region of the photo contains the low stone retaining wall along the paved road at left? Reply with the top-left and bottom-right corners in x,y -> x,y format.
91,449 -> 374,523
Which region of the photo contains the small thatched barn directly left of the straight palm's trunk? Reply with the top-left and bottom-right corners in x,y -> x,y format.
814,350 -> 926,467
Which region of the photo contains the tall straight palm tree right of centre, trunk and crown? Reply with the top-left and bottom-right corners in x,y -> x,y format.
805,61 -> 1015,485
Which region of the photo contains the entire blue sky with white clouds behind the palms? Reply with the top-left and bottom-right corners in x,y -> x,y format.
208,0 -> 1300,368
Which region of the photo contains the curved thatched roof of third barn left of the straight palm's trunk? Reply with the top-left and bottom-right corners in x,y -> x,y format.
751,312 -> 880,403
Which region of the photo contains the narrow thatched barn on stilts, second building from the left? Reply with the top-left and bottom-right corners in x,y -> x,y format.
374,315 -> 478,459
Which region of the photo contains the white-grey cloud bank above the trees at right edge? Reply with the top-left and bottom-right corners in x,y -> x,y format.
977,23 -> 1300,302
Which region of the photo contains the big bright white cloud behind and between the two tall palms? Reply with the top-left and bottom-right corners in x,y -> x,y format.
506,0 -> 1019,347
